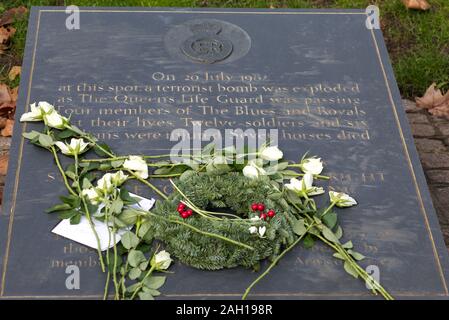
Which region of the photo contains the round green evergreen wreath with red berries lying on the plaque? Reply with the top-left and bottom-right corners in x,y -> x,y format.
142,171 -> 295,270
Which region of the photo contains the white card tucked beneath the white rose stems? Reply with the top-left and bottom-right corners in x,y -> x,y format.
51,193 -> 155,251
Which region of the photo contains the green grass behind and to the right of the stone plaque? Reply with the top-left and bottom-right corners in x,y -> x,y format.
0,0 -> 449,98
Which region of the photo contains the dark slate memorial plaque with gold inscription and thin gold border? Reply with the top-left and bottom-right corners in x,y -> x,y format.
0,7 -> 449,299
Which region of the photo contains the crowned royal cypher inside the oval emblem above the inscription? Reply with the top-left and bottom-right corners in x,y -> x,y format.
181,22 -> 233,63
